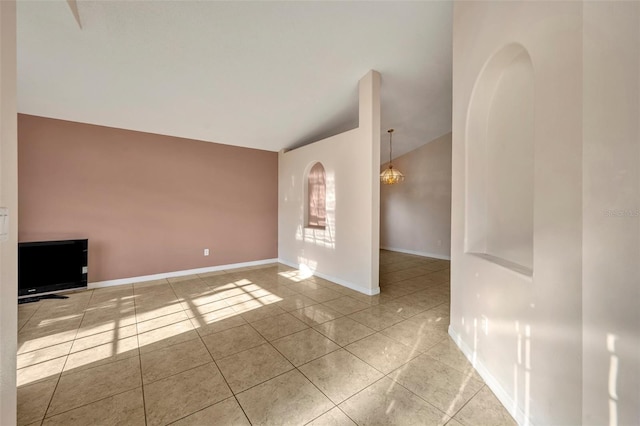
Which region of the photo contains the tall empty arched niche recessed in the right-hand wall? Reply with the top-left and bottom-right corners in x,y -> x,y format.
465,43 -> 535,275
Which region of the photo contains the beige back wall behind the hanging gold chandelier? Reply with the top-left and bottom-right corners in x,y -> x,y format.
380,133 -> 451,259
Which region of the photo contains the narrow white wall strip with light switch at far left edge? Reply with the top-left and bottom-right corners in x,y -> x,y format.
0,1 -> 18,425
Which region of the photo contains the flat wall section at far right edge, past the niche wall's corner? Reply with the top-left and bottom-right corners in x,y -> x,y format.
582,2 -> 640,425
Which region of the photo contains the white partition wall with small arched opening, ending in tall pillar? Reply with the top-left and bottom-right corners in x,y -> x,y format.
278,71 -> 380,294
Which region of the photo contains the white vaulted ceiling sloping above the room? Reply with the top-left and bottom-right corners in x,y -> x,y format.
18,0 -> 452,160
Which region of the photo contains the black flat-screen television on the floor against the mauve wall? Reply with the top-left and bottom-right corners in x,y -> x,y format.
18,239 -> 88,299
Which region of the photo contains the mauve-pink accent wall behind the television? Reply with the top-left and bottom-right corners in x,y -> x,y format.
18,114 -> 278,282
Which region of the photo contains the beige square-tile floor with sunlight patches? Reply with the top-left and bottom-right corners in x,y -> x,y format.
17,251 -> 515,426
